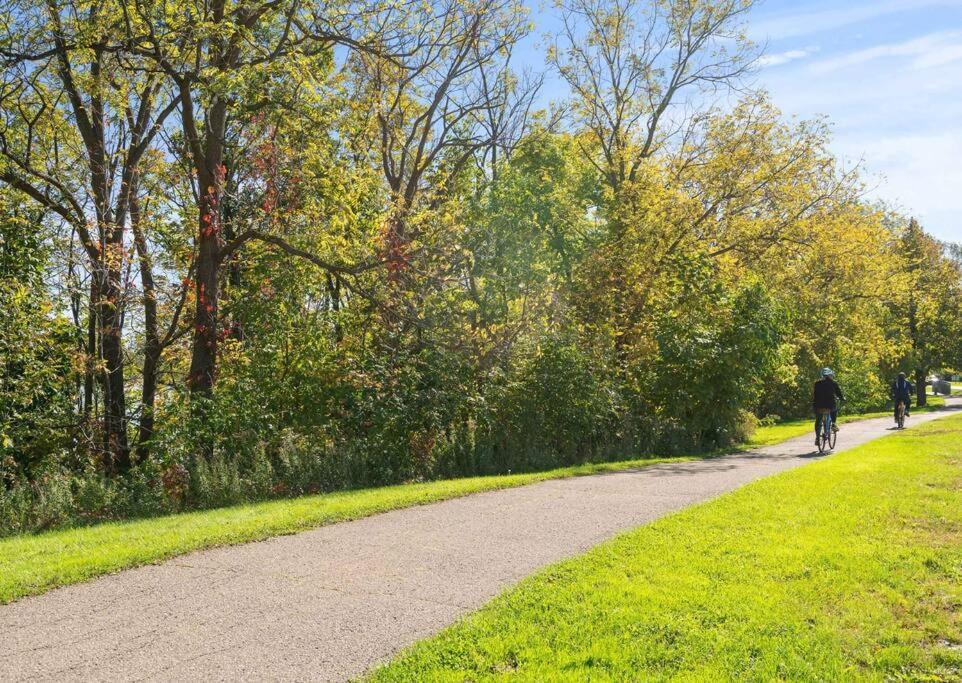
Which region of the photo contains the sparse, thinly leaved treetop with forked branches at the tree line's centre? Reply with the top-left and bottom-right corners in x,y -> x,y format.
355,0 -> 535,261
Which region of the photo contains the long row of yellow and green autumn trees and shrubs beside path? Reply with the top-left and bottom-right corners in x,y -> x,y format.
0,0 -> 962,531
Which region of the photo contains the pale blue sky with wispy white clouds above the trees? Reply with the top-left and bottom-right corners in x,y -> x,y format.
522,0 -> 962,242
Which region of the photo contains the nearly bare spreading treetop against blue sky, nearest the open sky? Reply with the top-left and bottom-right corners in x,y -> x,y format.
548,0 -> 755,193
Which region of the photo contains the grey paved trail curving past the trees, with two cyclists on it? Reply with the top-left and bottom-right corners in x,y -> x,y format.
0,400 -> 962,681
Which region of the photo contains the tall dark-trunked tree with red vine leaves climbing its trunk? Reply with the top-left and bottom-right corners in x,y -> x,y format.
126,0 -> 404,394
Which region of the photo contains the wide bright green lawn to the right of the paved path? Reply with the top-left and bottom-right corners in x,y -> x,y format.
372,416 -> 962,681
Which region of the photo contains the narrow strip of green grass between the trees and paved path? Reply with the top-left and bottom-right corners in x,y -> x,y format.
0,458 -> 690,604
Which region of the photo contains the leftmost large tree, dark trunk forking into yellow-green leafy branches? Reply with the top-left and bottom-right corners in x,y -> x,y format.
0,0 -> 178,471
